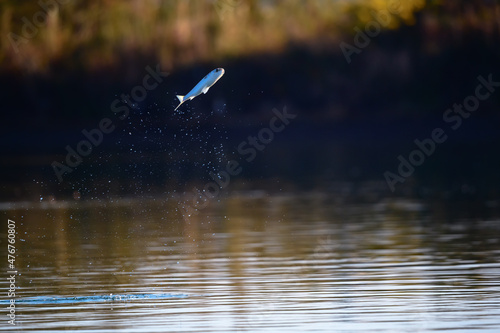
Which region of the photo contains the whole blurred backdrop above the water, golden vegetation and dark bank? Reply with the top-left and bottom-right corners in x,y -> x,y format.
0,0 -> 500,212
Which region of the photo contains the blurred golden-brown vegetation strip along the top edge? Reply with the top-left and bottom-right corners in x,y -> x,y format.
0,0 -> 500,73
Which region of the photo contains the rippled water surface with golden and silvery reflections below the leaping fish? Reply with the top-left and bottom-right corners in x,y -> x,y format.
0,195 -> 500,332
